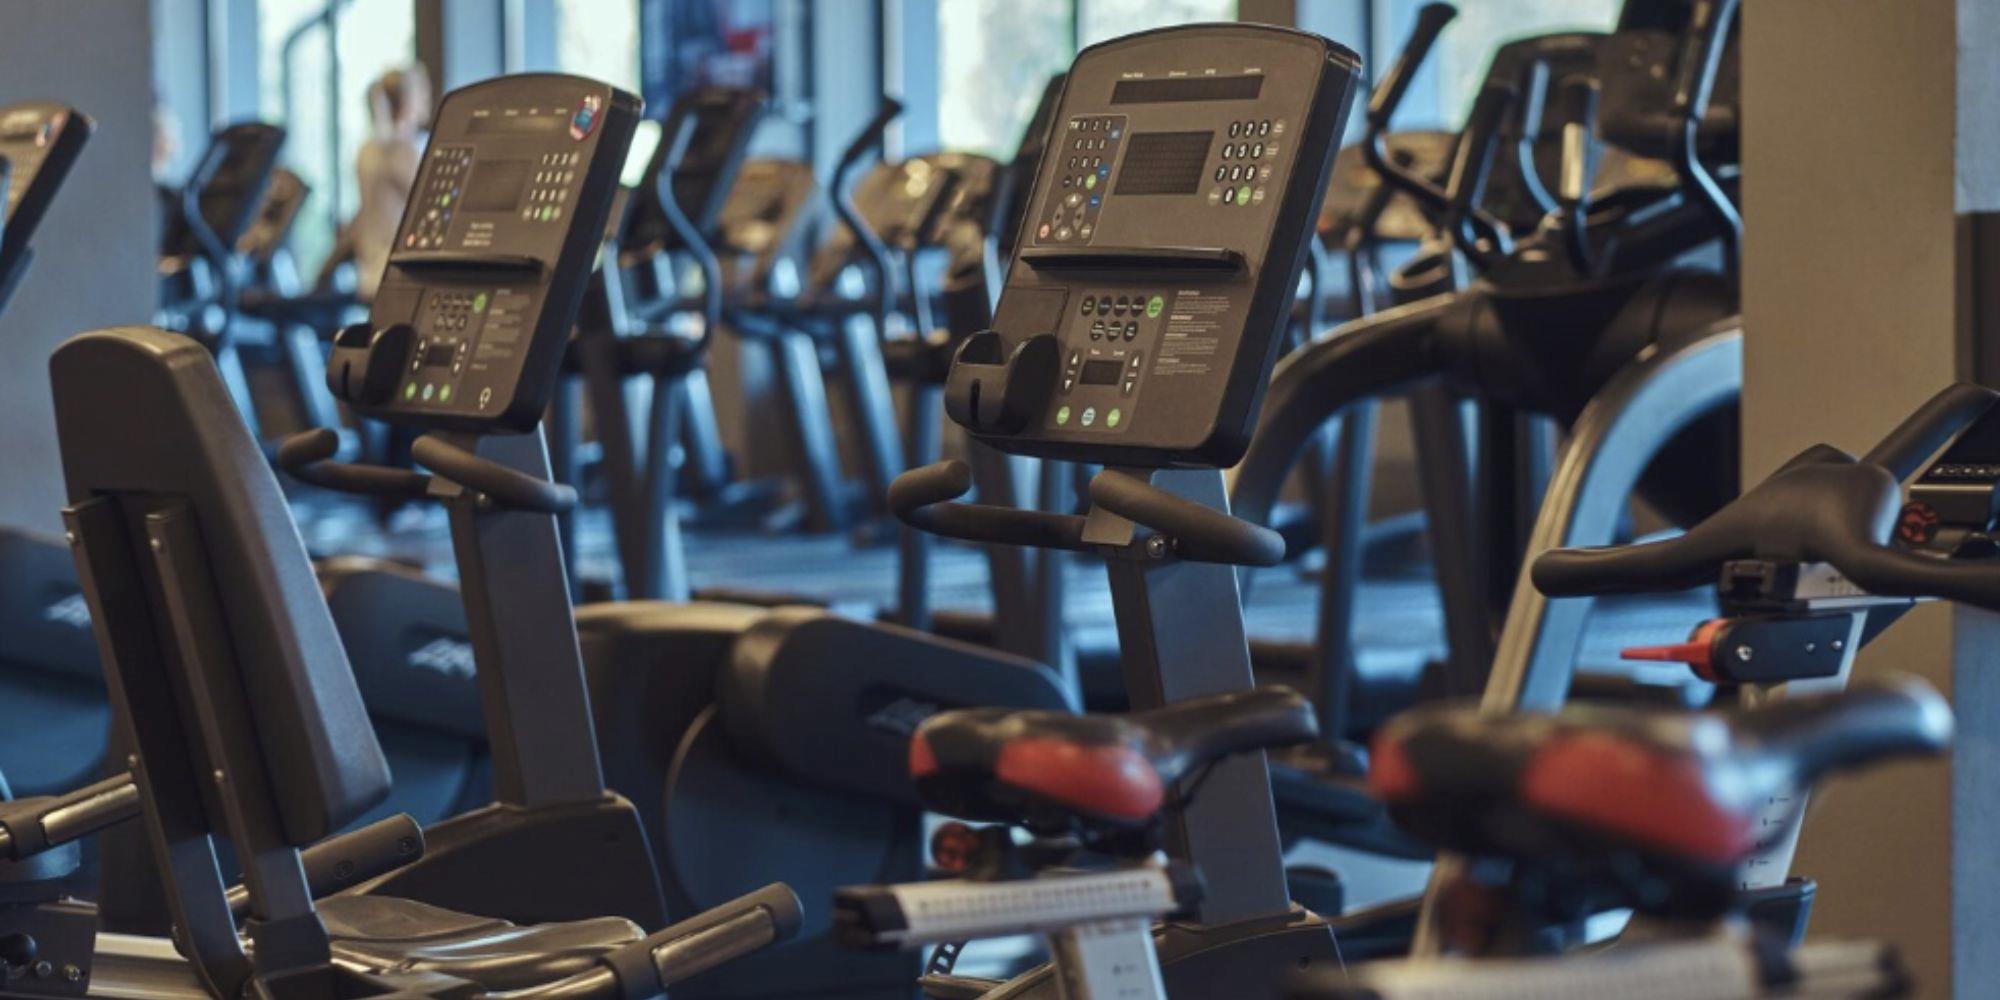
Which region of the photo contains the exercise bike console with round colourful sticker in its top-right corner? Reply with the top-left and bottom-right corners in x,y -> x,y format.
326,74 -> 640,432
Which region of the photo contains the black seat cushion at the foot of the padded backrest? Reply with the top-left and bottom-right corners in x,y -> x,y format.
318,896 -> 644,990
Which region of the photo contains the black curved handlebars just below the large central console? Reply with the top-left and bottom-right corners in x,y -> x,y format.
888,460 -> 1284,566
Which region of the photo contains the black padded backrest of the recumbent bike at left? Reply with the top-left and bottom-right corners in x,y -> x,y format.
50,326 -> 390,846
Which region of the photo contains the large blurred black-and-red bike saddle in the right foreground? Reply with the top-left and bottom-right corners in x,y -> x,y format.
1368,680 -> 1952,868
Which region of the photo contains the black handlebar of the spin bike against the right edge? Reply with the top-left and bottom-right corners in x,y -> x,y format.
1532,386 -> 2000,610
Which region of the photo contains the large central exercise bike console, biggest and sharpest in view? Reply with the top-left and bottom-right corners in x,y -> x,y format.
946,24 -> 1360,466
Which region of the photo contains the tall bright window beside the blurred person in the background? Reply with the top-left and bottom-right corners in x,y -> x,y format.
258,0 -> 416,274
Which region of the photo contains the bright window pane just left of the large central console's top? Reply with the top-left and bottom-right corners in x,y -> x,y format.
938,0 -> 1076,158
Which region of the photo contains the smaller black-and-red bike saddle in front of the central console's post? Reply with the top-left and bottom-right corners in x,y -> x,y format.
910,688 -> 1320,830
